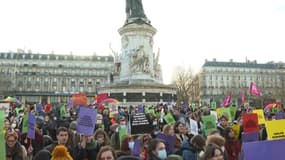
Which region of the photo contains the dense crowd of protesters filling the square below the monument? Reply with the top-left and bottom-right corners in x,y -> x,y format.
3,104 -> 282,160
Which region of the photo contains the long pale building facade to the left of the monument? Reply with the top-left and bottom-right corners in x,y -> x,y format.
0,53 -> 114,103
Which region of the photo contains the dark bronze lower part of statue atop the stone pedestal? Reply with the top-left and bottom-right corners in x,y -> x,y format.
126,0 -> 146,19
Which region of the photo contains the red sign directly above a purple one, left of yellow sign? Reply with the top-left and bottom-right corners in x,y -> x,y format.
242,113 -> 259,133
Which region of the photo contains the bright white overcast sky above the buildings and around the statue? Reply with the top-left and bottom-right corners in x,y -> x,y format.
0,0 -> 285,83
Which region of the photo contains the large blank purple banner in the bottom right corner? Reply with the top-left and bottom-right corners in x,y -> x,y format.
242,140 -> 285,160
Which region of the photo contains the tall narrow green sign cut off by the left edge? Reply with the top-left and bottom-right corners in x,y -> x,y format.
0,108 -> 6,160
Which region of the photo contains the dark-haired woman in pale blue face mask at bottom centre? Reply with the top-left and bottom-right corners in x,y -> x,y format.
148,138 -> 167,160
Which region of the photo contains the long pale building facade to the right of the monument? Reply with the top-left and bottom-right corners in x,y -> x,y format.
199,59 -> 285,106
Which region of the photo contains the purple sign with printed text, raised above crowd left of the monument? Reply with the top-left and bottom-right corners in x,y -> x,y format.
77,106 -> 97,136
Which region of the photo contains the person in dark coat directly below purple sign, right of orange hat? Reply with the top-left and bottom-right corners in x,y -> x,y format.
75,136 -> 99,160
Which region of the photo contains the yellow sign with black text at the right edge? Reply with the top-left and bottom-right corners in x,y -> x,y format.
265,119 -> 285,140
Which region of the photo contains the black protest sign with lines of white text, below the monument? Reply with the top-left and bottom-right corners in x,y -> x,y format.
131,113 -> 153,134
